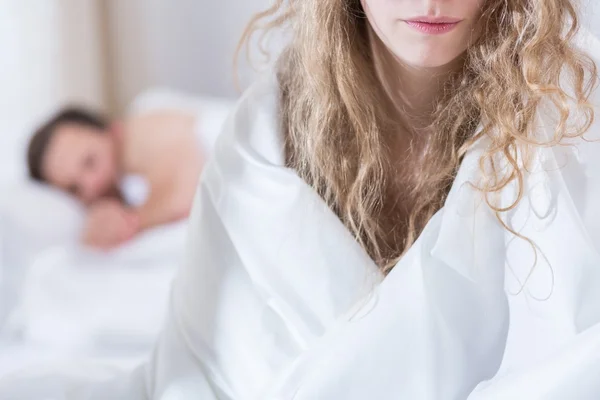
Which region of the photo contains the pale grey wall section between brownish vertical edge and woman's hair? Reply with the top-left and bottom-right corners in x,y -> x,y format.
107,0 -> 271,109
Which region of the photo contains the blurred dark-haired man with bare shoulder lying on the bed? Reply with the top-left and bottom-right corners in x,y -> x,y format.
27,108 -> 209,249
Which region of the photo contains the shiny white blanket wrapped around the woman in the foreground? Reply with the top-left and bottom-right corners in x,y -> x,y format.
0,33 -> 600,400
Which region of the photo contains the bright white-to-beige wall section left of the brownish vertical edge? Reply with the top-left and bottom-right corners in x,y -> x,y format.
0,0 -> 104,181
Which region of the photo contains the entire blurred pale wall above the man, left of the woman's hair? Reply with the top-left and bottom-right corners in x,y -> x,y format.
0,0 -> 270,179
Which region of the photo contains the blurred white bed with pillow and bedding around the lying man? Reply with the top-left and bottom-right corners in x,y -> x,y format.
0,88 -> 232,376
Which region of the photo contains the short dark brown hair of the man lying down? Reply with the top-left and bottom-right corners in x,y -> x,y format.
27,107 -> 108,182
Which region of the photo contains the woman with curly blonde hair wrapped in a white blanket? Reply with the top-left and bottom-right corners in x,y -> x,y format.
0,0 -> 600,399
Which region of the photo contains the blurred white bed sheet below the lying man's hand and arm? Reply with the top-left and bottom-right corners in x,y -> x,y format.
0,222 -> 187,376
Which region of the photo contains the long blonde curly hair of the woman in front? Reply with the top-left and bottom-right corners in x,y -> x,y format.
240,0 -> 597,273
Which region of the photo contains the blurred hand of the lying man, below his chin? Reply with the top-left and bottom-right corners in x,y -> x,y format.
83,199 -> 139,250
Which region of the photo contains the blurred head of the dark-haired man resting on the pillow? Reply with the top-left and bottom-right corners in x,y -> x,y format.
27,108 -> 118,203
